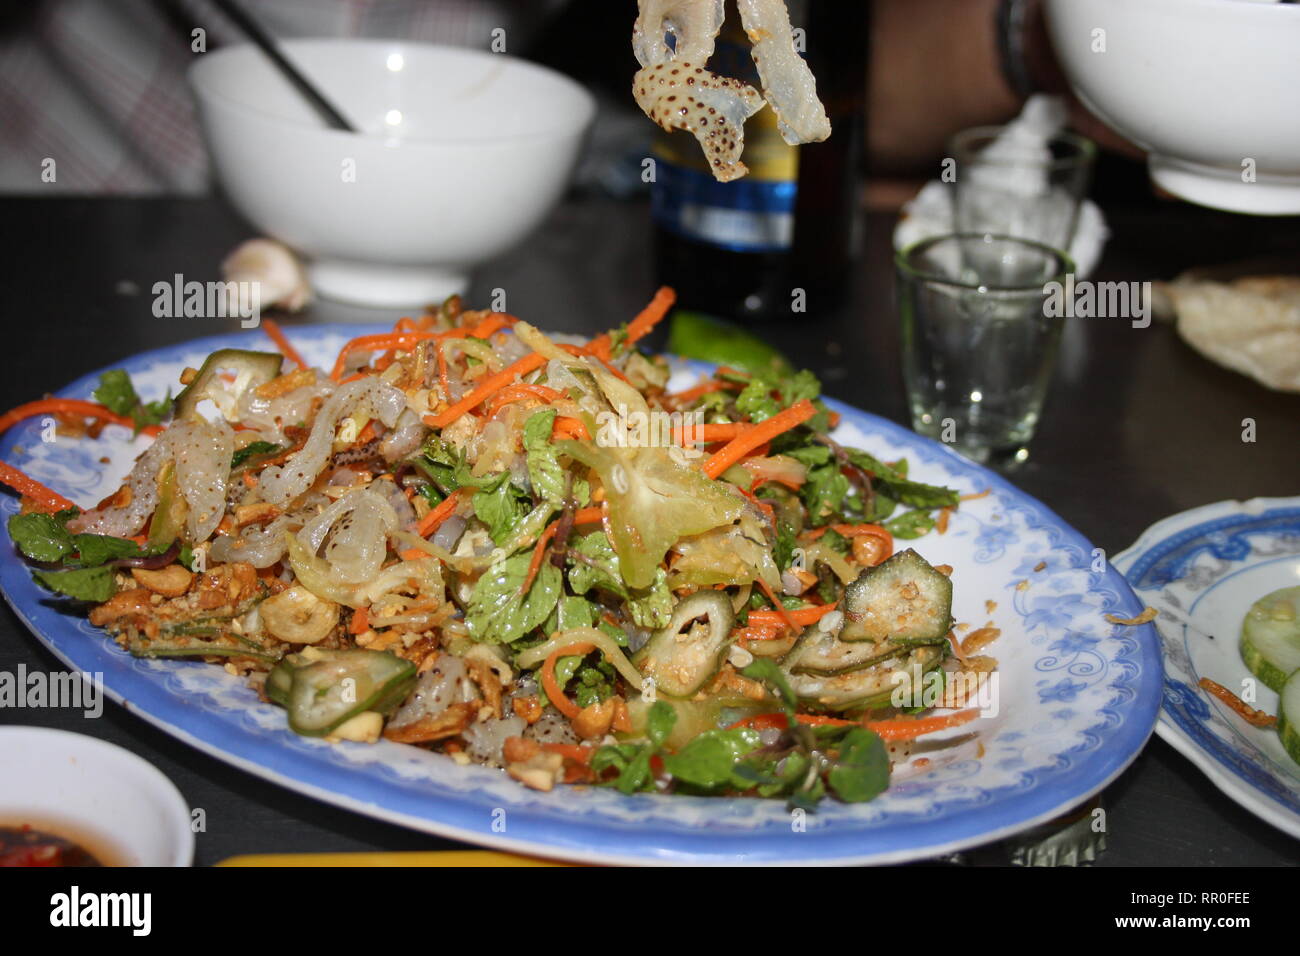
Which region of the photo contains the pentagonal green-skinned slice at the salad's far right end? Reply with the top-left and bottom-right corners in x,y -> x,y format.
840,548 -> 953,644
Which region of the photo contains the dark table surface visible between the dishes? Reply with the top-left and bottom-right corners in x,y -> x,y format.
0,199 -> 1300,866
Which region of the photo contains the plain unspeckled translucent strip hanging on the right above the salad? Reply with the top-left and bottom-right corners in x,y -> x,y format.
736,0 -> 831,146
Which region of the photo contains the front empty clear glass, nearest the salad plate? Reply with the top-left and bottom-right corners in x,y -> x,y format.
894,234 -> 1074,466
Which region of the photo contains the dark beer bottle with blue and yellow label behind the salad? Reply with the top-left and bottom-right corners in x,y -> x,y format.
650,0 -> 870,321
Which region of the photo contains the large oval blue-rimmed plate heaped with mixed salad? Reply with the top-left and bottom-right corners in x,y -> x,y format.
0,289 -> 1161,864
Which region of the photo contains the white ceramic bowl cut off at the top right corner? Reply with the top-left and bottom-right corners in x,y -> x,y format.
1047,0 -> 1300,215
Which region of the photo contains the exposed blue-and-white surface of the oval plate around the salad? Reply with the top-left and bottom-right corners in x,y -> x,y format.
0,326 -> 1161,864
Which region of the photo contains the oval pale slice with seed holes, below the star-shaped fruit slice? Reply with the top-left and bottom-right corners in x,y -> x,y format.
632,591 -> 736,697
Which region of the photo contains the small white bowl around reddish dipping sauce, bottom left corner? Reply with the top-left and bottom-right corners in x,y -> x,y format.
0,726 -> 194,866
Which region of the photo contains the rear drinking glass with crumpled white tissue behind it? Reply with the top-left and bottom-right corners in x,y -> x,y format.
949,126 -> 1097,248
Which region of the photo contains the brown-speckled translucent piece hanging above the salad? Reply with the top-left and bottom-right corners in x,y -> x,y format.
632,60 -> 763,182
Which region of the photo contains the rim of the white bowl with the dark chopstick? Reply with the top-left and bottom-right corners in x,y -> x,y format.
186,36 -> 595,148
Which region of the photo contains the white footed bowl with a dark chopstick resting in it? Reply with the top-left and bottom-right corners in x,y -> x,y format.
190,40 -> 595,306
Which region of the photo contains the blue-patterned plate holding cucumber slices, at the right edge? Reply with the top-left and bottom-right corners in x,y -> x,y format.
1114,498 -> 1300,838
